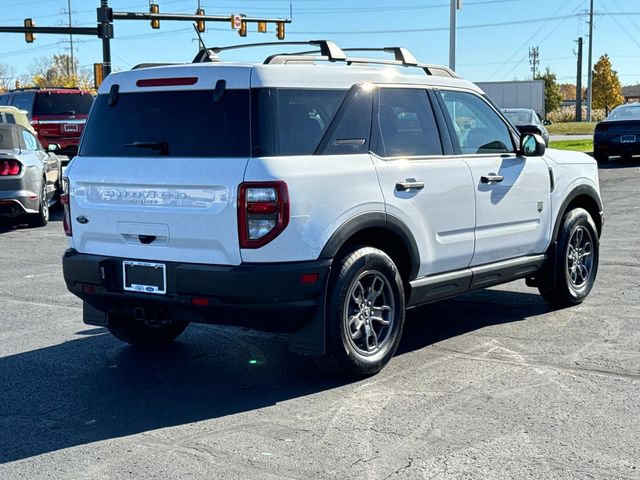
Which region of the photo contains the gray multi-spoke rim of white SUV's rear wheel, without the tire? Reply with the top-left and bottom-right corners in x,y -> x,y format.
343,270 -> 395,356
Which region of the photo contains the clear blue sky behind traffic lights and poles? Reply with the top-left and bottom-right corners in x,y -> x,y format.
0,0 -> 640,85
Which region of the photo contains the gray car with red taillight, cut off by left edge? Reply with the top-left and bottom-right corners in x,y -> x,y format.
0,123 -> 62,227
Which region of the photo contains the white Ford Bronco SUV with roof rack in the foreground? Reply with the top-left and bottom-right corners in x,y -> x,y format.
62,41 -> 603,376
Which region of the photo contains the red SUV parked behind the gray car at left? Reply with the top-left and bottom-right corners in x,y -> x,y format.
0,88 -> 93,158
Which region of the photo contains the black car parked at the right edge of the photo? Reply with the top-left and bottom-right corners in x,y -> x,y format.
593,103 -> 640,162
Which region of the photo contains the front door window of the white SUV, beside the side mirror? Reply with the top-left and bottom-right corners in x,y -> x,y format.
438,91 -> 515,154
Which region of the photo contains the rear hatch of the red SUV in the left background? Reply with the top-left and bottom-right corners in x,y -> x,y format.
31,90 -> 93,147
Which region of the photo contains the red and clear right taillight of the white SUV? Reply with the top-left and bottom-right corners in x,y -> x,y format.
238,181 -> 289,248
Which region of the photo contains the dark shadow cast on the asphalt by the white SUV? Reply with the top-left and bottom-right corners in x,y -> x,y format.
0,290 -> 548,463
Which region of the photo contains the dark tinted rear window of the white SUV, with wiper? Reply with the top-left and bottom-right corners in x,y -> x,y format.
80,90 -> 251,157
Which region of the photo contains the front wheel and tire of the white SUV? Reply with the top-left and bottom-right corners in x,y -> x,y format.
538,208 -> 600,307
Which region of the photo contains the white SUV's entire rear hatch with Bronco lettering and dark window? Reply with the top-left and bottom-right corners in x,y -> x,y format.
67,65 -> 251,265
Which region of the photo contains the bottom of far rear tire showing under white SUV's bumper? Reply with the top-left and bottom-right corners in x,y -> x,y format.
107,315 -> 189,347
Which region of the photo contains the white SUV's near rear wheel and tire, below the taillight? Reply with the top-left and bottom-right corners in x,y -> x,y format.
316,247 -> 405,377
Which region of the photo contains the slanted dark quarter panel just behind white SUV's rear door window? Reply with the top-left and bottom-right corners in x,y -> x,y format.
318,87 -> 373,155
